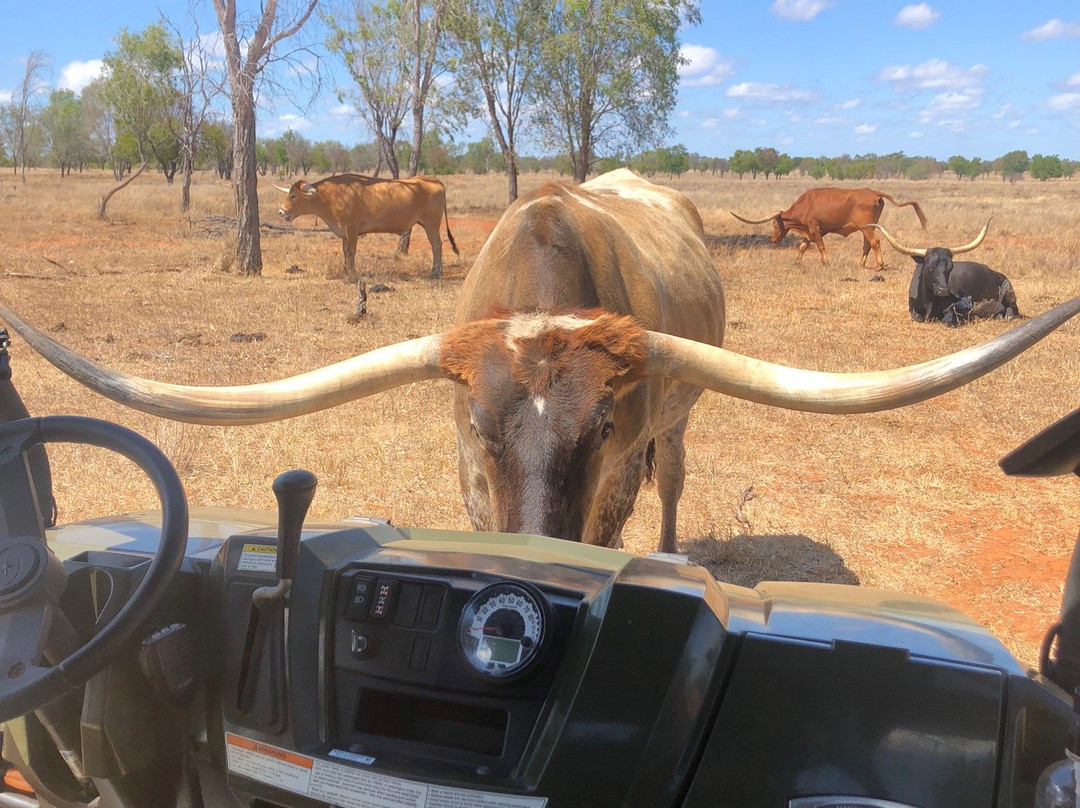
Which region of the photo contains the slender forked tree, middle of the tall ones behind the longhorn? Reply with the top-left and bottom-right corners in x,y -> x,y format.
446,0 -> 550,202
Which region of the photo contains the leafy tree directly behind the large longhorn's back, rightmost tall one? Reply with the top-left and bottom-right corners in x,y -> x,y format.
534,0 -> 701,181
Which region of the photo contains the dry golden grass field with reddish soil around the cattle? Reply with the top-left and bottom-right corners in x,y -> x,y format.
0,172 -> 1080,661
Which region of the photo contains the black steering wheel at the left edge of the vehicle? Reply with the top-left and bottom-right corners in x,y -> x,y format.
0,416 -> 188,722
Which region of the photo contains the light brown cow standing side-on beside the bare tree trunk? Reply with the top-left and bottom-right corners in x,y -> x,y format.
274,174 -> 458,278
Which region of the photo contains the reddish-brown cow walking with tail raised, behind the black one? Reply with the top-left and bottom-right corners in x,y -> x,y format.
728,188 -> 927,269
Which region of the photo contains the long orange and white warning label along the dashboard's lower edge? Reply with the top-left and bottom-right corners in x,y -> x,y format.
225,732 -> 548,808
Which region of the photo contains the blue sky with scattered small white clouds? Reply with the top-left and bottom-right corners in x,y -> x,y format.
0,0 -> 1080,159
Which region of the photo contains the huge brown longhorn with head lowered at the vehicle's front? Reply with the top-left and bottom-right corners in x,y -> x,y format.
0,170 -> 1080,551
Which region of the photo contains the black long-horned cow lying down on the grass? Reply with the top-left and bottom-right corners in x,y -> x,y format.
877,221 -> 1020,325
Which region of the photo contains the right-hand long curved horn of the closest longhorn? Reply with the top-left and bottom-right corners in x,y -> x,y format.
648,297 -> 1080,414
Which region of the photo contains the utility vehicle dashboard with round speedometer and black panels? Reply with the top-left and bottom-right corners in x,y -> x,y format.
31,511 -> 1068,808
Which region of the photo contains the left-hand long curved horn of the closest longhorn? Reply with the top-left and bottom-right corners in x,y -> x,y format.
0,304 -> 446,425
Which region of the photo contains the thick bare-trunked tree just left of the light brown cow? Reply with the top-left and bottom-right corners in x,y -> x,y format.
214,0 -> 318,275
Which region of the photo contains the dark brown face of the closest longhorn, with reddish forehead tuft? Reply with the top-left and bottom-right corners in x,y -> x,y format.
441,318 -> 644,541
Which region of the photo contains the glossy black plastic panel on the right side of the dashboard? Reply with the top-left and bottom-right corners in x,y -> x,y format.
685,635 -> 1007,808
